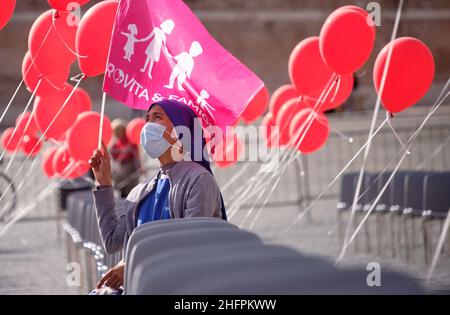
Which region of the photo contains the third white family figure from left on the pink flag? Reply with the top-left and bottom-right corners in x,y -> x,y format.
164,41 -> 203,91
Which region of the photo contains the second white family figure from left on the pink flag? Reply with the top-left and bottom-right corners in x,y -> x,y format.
140,20 -> 175,79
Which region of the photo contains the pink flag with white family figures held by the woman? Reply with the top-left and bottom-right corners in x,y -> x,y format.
103,0 -> 264,130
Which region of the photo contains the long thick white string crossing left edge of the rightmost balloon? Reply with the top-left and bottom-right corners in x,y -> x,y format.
337,0 -> 404,261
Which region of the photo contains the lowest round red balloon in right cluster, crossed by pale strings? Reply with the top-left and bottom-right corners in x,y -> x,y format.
289,108 -> 330,154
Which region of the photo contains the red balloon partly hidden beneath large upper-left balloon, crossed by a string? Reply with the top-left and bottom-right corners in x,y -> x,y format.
22,52 -> 70,96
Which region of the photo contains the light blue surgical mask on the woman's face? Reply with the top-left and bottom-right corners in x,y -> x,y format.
141,122 -> 171,159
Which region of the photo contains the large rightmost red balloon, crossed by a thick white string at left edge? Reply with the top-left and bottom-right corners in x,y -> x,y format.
373,37 -> 435,114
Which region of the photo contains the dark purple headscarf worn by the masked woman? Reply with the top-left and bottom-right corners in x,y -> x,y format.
148,100 -> 227,220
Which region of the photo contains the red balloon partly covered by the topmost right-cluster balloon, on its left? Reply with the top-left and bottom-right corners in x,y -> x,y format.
289,37 -> 333,95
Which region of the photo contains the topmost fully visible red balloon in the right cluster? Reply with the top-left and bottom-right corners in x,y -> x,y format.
320,9 -> 375,74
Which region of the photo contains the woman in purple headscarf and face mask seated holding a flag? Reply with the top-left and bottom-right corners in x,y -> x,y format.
89,100 -> 226,289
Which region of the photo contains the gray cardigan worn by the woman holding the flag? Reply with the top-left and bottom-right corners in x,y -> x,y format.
93,161 -> 222,254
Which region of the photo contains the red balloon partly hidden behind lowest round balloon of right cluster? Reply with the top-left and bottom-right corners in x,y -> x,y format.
275,96 -> 310,145
